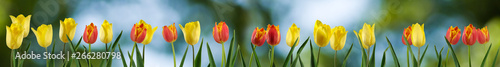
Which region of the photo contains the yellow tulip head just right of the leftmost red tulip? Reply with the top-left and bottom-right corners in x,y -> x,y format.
99,20 -> 113,43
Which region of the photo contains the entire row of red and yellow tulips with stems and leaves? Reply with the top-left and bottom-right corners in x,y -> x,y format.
2,15 -> 498,67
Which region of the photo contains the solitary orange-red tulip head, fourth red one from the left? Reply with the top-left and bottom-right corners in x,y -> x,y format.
212,21 -> 229,44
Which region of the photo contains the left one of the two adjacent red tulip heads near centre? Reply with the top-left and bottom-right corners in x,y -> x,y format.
251,27 -> 267,46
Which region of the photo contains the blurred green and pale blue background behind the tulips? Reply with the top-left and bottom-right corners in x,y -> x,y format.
0,0 -> 500,67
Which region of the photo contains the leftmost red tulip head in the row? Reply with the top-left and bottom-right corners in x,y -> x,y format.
83,23 -> 97,44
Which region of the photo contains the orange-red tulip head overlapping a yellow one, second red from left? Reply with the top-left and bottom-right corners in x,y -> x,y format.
130,20 -> 148,43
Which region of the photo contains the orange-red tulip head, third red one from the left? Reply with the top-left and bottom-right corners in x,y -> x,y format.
162,23 -> 177,43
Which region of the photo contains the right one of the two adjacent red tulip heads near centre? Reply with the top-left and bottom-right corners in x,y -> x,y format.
266,24 -> 281,46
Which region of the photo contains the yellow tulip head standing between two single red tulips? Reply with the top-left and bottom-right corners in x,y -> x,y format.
179,21 -> 200,45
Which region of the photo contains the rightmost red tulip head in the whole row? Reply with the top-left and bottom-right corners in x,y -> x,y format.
476,26 -> 490,44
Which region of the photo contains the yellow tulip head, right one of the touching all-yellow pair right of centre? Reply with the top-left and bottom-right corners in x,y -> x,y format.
330,26 -> 348,50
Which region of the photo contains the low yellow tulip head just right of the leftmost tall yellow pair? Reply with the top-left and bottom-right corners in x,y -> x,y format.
31,24 -> 53,48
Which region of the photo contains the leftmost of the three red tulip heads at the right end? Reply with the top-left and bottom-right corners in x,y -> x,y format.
446,26 -> 462,45
